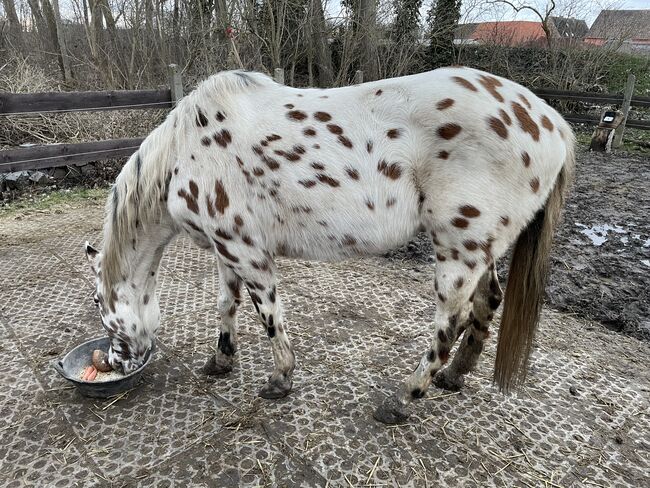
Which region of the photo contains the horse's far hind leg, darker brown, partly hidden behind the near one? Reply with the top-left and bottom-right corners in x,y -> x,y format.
434,263 -> 503,391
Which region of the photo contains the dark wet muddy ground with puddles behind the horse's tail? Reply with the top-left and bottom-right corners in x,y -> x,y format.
387,151 -> 650,340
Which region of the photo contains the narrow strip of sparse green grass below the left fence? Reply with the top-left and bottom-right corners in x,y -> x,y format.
0,188 -> 109,218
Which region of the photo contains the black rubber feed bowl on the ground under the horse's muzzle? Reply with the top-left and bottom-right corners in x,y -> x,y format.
53,337 -> 156,398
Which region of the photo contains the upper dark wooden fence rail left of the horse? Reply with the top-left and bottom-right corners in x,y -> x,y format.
0,88 -> 172,114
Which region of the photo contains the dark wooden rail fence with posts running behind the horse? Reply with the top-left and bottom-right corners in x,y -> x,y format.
0,65 -> 650,173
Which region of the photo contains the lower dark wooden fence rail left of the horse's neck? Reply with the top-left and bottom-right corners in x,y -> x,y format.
0,138 -> 143,173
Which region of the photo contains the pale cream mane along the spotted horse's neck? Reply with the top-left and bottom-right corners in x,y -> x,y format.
101,71 -> 273,299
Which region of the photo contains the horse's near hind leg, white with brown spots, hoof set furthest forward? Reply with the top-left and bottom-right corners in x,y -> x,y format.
374,256 -> 487,424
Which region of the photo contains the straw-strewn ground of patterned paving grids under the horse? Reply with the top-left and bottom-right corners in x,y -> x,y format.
0,200 -> 650,487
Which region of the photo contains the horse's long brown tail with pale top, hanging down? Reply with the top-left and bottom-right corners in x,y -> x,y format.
494,134 -> 575,391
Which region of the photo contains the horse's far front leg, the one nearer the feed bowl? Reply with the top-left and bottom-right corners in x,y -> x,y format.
203,259 -> 242,375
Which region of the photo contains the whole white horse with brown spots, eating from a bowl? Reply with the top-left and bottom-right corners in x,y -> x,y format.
85,67 -> 575,424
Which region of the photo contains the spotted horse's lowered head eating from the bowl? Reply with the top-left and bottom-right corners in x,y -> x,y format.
85,242 -> 160,374
